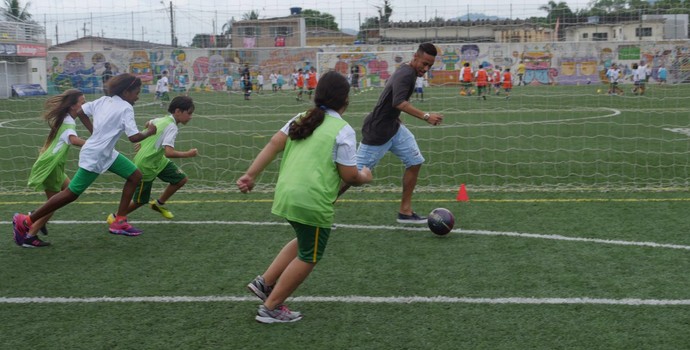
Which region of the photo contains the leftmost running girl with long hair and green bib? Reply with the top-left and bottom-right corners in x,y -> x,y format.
22,89 -> 86,248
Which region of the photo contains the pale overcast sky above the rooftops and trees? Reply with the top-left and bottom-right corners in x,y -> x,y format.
29,0 -> 588,45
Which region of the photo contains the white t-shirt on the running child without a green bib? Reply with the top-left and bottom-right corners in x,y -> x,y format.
79,96 -> 139,174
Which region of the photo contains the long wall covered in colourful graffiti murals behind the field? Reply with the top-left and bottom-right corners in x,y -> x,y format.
46,41 -> 690,94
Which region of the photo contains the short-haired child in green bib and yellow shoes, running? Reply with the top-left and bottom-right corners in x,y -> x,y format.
107,96 -> 198,224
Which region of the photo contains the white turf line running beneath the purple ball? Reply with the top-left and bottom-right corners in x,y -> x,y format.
21,220 -> 690,250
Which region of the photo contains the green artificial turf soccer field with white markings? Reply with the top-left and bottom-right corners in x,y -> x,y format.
0,86 -> 690,349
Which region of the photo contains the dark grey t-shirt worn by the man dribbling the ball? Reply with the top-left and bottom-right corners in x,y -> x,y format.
362,63 -> 417,146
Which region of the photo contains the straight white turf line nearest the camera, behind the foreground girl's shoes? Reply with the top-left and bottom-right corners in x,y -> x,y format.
0,295 -> 690,306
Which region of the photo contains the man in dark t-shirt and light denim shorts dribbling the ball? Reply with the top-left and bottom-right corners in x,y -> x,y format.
340,43 -> 443,224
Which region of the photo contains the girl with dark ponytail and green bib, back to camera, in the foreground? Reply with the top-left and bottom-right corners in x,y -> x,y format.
237,72 -> 372,323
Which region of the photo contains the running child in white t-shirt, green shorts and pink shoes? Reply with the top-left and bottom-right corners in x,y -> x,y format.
12,73 -> 156,246
